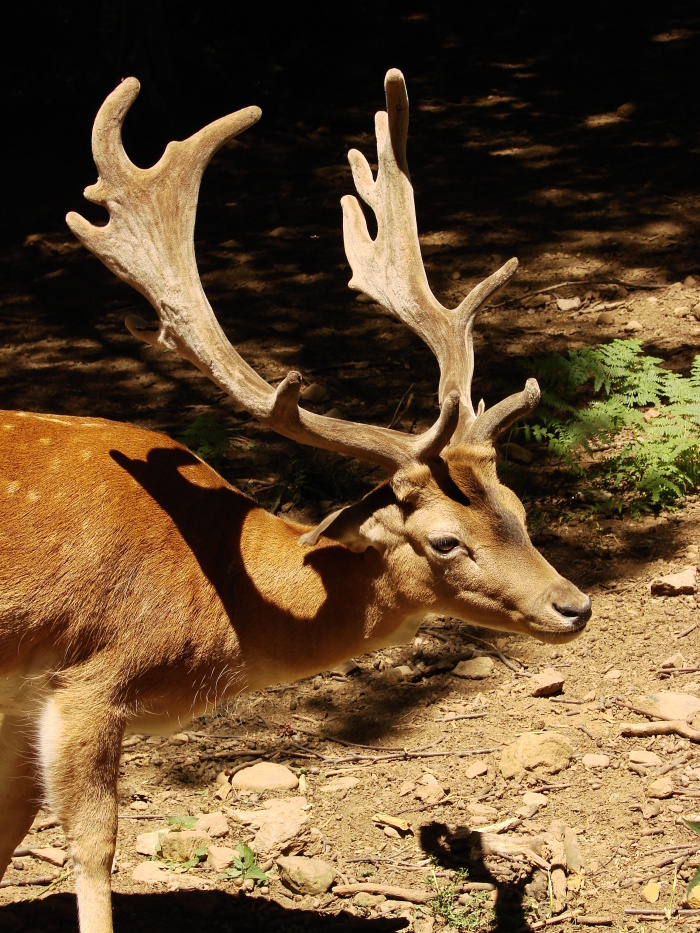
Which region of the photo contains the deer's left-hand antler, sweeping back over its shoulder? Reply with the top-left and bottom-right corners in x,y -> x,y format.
66,78 -> 459,472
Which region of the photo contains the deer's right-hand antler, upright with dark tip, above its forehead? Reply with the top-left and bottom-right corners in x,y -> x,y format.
342,68 -> 540,444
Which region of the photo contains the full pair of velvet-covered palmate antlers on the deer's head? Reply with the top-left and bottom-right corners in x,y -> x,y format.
66,71 -> 539,472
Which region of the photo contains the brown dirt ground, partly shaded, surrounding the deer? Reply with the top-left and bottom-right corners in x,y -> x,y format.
0,9 -> 700,933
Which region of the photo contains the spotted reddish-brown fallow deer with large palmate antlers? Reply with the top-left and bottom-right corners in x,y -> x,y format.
0,69 -> 591,933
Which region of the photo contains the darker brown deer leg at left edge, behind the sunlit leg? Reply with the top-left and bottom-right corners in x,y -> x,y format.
0,716 -> 42,878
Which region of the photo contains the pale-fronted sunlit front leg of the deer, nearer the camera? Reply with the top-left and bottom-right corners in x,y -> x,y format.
39,687 -> 124,933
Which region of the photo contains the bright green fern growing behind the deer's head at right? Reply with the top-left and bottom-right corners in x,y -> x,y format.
518,340 -> 700,512
